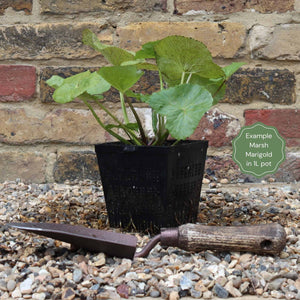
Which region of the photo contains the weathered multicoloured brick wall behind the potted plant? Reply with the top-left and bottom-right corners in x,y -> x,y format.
0,0 -> 300,182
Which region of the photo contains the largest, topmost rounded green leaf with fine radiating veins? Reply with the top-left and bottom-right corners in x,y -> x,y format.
154,36 -> 225,86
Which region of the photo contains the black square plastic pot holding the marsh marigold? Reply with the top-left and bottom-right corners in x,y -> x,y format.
95,141 -> 208,232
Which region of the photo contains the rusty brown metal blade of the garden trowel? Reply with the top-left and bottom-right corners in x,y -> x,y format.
7,223 -> 137,259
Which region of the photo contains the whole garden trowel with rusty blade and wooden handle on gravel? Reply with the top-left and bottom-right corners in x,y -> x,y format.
8,223 -> 286,259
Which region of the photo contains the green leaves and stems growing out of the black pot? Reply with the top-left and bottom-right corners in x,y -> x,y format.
47,29 -> 244,145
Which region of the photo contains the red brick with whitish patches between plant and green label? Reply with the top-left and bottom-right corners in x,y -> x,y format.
190,108 -> 241,147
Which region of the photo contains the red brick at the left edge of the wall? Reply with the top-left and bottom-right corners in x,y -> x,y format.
0,65 -> 36,102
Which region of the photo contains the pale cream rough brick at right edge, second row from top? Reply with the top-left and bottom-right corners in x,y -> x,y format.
249,24 -> 300,61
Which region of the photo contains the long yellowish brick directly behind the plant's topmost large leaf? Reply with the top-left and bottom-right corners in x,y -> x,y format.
117,22 -> 246,58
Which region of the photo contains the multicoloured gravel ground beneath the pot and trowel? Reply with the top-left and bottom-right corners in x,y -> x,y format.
0,180 -> 300,300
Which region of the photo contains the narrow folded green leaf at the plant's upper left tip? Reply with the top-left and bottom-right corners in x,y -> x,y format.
83,29 -> 135,66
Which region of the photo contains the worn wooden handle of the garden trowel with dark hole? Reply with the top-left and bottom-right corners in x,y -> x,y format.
178,223 -> 286,254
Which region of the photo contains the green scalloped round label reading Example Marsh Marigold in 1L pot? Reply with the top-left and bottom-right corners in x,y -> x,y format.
232,122 -> 285,178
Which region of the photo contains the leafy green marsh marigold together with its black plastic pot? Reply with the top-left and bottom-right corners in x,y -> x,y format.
47,29 -> 243,231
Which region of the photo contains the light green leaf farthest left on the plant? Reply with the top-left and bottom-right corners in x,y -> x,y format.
47,71 -> 110,103
